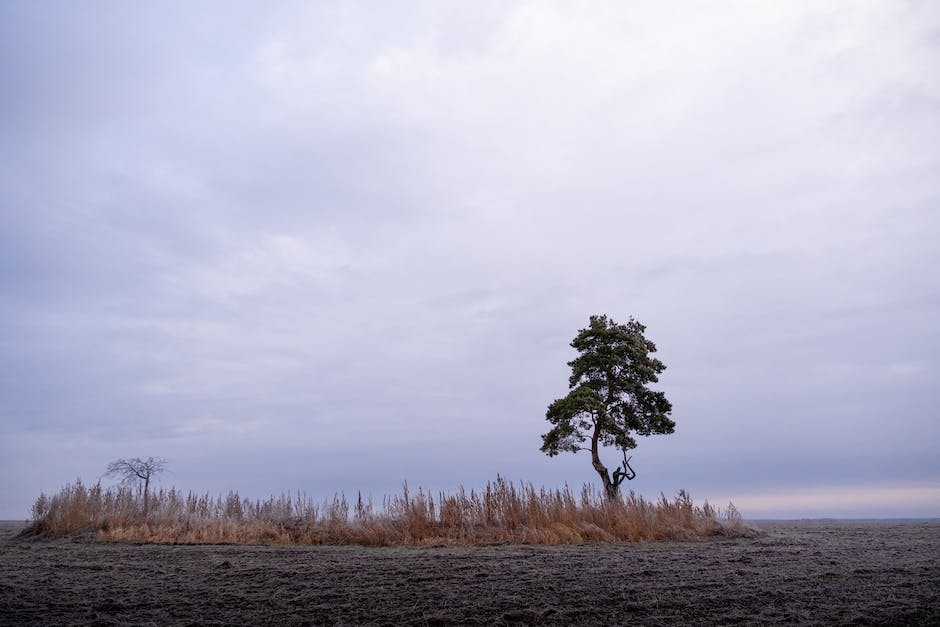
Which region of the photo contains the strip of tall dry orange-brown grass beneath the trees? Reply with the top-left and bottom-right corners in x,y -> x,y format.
23,476 -> 747,545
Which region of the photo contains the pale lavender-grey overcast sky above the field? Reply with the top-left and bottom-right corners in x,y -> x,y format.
0,0 -> 940,519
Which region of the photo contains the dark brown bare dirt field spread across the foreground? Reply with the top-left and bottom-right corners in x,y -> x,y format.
0,522 -> 940,625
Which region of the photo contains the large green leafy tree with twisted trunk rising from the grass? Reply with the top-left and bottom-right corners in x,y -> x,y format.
541,315 -> 676,498
